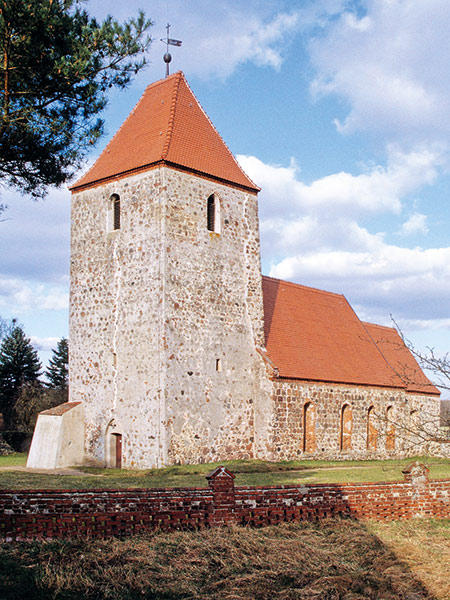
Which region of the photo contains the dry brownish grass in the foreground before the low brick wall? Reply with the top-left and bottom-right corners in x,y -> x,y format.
0,520 -> 450,600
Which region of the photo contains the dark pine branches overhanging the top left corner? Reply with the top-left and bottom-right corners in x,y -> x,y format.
0,0 -> 151,196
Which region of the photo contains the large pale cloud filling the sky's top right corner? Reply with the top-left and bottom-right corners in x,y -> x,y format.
310,0 -> 450,141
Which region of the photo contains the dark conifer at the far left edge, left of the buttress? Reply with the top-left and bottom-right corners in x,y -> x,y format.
0,327 -> 41,429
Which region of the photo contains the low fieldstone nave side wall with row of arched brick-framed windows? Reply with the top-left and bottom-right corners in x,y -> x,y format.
268,379 -> 439,460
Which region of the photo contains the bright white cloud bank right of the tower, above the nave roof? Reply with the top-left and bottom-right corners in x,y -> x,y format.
240,152 -> 450,323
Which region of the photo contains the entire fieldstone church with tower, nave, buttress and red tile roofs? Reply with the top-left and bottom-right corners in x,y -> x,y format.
28,72 -> 439,469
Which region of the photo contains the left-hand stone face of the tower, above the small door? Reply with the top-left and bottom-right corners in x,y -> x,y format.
69,170 -> 165,467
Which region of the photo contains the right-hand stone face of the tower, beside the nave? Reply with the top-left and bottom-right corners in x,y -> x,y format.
164,169 -> 264,464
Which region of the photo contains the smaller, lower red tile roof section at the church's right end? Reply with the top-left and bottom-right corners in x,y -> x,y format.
363,323 -> 440,394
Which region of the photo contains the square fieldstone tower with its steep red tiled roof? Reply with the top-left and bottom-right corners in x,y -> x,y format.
70,73 -> 264,468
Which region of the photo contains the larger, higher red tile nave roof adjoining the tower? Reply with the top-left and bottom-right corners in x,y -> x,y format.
263,277 -> 438,393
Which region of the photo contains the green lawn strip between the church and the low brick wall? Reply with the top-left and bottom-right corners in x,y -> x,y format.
0,454 -> 450,489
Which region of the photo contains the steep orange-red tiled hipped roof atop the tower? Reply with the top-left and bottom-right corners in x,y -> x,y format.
71,71 -> 259,192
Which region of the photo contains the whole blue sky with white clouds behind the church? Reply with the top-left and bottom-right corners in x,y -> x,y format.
0,0 -> 450,394
